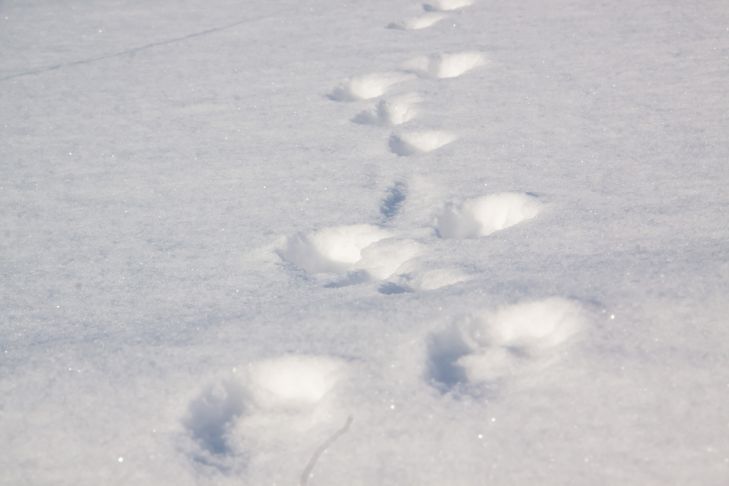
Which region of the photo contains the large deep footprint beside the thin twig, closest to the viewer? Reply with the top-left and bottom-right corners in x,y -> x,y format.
182,355 -> 347,472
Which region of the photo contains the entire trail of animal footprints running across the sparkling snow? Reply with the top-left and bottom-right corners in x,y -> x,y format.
183,0 -> 587,478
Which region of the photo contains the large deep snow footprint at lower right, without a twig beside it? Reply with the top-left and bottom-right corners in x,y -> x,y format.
426,297 -> 585,392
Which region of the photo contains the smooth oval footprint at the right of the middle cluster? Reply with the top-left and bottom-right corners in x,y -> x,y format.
435,192 -> 544,238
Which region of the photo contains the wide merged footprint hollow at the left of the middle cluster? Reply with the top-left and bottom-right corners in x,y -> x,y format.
279,224 -> 423,287
